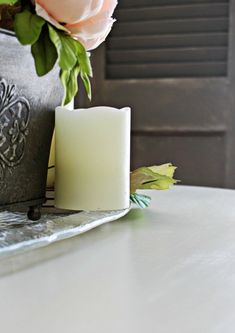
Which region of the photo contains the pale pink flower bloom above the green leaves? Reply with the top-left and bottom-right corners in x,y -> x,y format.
35,0 -> 117,50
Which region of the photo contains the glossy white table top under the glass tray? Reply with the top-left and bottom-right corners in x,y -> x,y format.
0,186 -> 235,333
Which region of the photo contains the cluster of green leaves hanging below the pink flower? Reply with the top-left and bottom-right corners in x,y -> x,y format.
14,9 -> 92,105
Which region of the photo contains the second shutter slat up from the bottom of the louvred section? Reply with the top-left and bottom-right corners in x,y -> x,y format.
107,47 -> 227,64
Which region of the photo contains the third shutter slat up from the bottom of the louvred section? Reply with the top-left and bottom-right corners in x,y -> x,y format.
107,32 -> 228,50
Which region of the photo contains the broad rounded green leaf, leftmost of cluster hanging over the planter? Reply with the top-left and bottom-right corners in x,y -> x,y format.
14,10 -> 45,45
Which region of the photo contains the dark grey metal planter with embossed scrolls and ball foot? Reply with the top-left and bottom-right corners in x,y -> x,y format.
0,29 -> 63,220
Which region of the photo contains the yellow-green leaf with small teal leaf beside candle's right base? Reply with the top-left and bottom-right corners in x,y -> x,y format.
130,163 -> 178,208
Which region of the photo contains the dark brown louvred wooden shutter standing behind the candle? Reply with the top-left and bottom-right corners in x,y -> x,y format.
76,0 -> 235,188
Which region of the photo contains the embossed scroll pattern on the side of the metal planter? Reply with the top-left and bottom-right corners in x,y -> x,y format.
0,79 -> 30,181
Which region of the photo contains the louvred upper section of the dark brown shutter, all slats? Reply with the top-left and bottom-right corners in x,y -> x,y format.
106,0 -> 229,79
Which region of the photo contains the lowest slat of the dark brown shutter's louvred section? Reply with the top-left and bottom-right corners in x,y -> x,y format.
107,62 -> 227,79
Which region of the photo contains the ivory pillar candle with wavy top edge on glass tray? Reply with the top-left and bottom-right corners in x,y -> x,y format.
55,106 -> 130,210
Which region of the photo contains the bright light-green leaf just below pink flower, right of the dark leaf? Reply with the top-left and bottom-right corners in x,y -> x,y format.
48,24 -> 77,70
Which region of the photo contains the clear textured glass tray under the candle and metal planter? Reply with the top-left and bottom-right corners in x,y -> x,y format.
0,206 -> 129,259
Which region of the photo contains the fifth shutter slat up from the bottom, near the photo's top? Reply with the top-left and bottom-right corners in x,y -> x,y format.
115,3 -> 228,22
